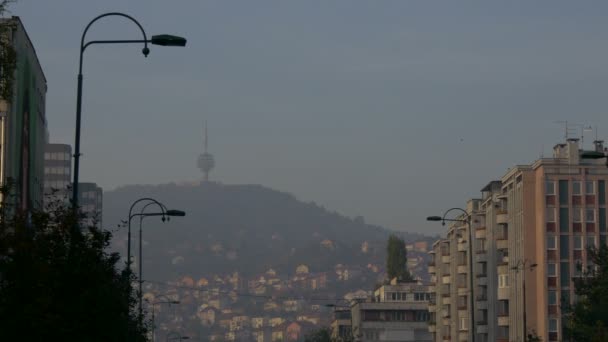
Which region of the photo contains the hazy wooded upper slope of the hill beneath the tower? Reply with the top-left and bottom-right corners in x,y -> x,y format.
103,183 -> 430,279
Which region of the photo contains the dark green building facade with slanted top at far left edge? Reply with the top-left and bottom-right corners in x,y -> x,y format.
0,17 -> 48,212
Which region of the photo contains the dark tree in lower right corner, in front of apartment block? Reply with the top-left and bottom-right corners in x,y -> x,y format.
563,243 -> 608,341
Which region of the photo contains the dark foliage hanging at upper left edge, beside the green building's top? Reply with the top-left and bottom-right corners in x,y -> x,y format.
0,0 -> 17,101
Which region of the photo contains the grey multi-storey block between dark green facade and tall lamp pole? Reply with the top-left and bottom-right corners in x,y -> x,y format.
44,144 -> 72,205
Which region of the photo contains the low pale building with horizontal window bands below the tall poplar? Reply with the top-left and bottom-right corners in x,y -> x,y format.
351,279 -> 433,342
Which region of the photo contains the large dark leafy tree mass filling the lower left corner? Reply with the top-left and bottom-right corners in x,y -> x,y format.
0,189 -> 147,341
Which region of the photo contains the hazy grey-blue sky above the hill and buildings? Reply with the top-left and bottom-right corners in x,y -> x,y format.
12,0 -> 608,233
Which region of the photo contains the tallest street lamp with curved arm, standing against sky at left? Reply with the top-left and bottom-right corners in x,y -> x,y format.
72,12 -> 186,212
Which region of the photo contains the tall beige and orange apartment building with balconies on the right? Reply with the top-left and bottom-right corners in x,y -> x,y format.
429,139 -> 608,342
